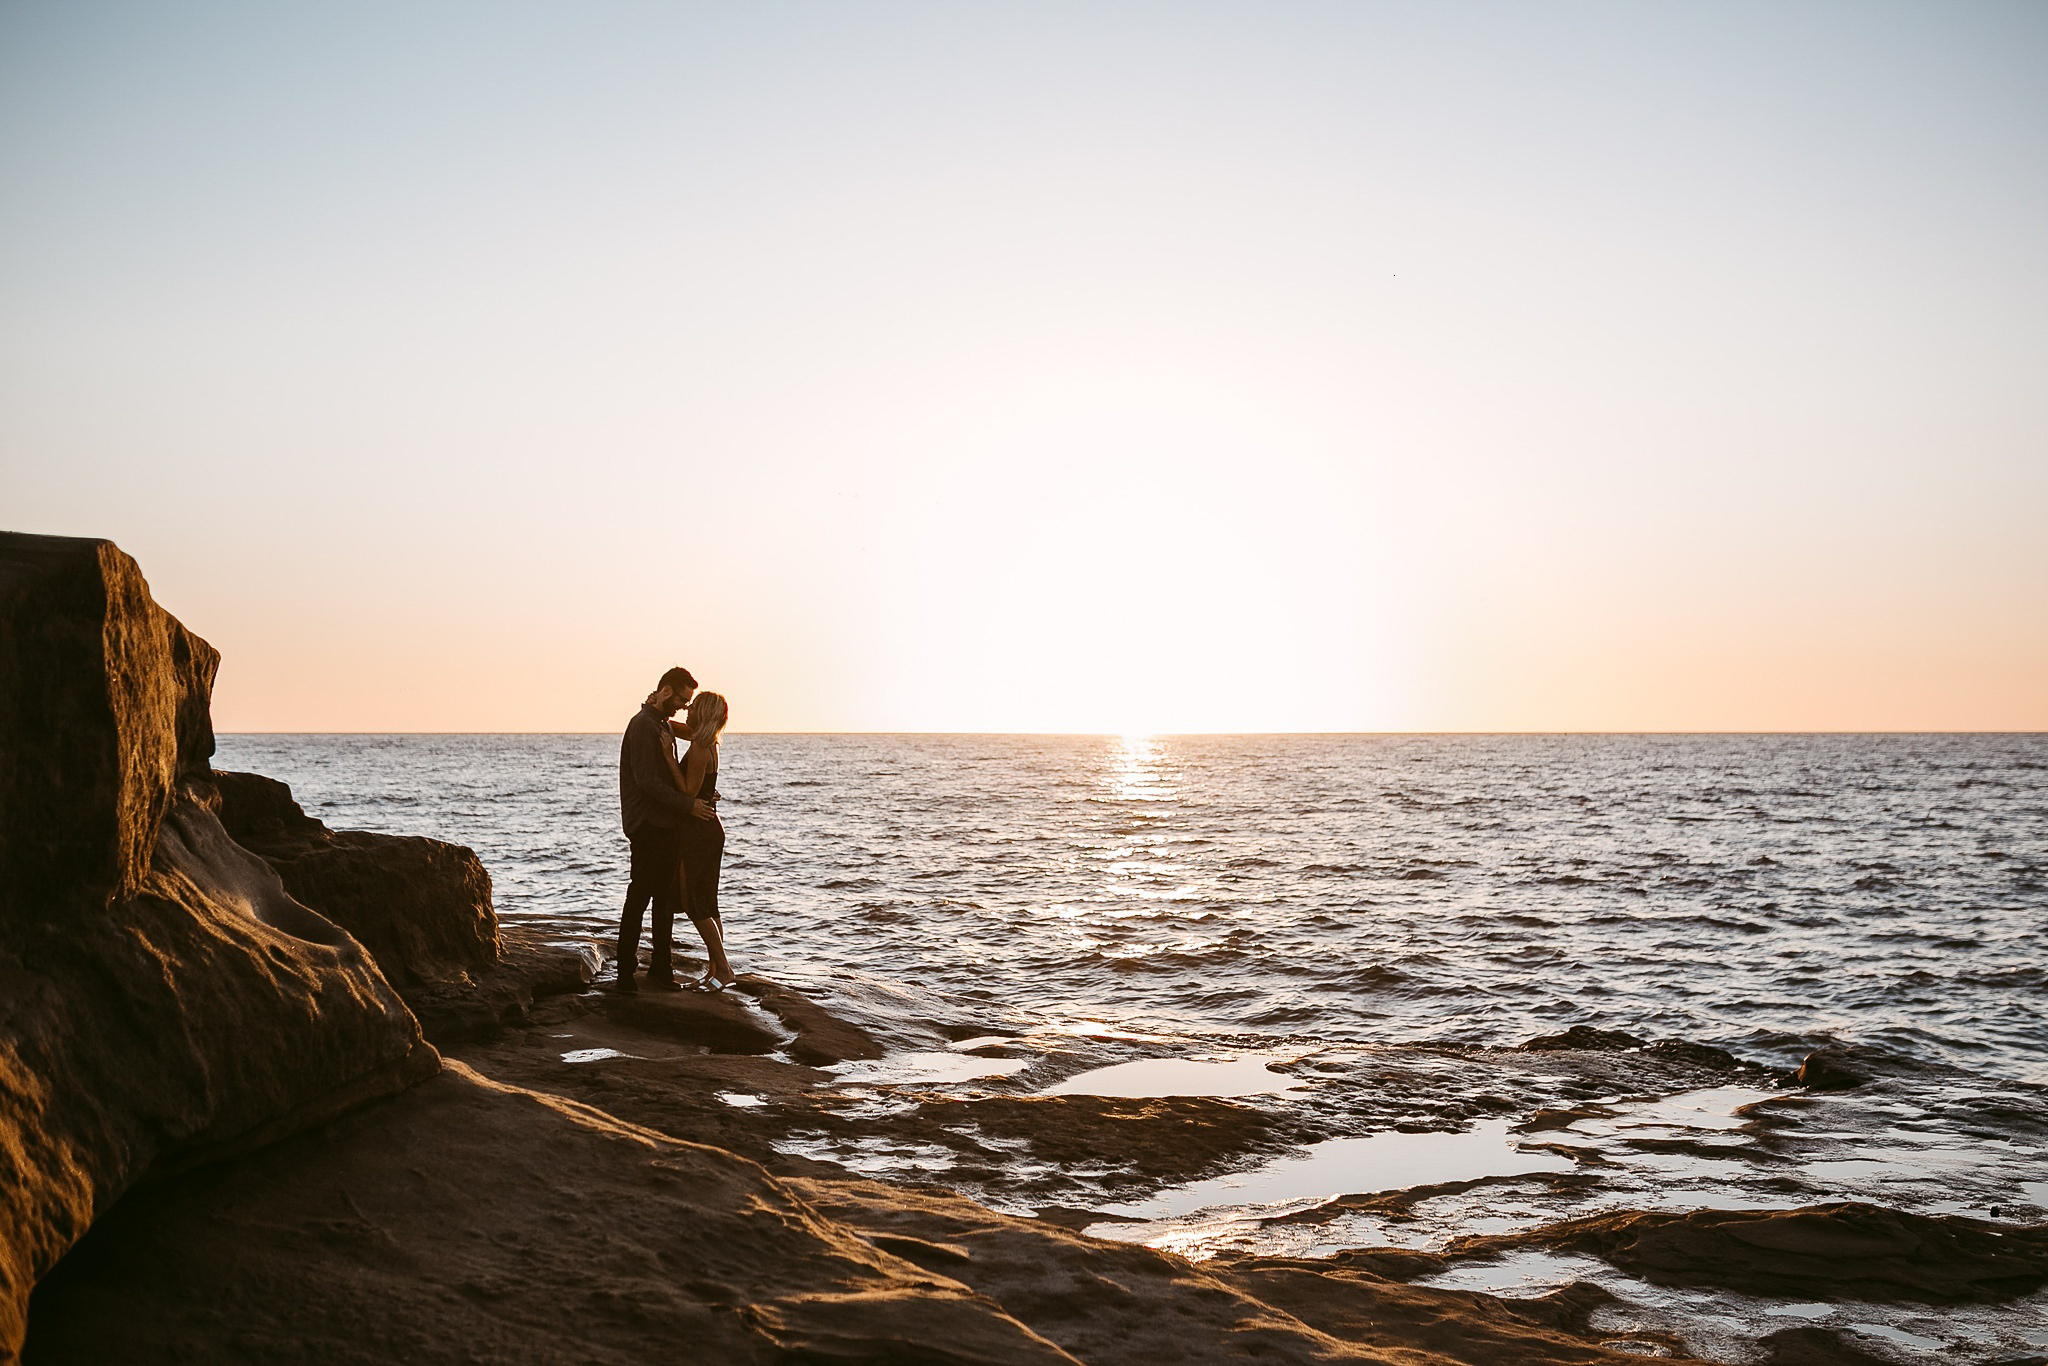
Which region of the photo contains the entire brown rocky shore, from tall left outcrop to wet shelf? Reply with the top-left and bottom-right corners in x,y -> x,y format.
0,537 -> 2048,1366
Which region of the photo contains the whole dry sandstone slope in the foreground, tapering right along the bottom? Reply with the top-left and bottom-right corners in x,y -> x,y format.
29,1059 -> 1695,1366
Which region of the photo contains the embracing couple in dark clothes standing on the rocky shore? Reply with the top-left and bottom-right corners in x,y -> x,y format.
618,668 -> 735,991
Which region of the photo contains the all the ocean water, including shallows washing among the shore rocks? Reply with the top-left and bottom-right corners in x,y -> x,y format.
217,735 -> 2048,1362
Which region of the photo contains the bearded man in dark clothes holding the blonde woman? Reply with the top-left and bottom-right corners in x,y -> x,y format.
618,666 -> 705,991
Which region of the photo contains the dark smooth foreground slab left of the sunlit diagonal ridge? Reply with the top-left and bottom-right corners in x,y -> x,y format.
29,1063 -> 1073,1366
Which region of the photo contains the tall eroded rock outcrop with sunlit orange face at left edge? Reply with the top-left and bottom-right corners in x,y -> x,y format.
0,532 -> 438,1360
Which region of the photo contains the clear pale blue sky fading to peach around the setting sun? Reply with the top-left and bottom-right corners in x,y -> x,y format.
0,0 -> 2048,731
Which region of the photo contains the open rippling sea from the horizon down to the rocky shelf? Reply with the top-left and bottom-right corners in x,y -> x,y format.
215,737 -> 2048,1081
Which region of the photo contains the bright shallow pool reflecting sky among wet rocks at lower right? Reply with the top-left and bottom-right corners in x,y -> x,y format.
1087,1085 -> 2048,1362
